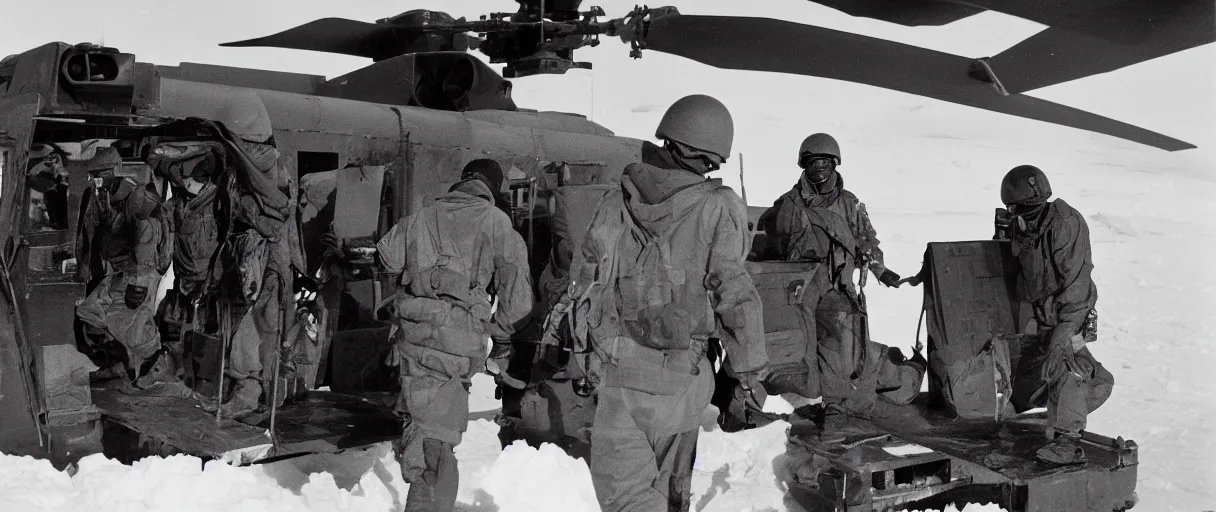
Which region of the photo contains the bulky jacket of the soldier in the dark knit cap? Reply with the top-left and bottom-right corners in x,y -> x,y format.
376,180 -> 533,359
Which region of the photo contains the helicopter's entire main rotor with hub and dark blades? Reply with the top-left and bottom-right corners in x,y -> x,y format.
221,0 -> 1216,151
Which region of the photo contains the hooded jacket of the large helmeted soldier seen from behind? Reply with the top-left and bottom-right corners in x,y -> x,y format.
570,144 -> 769,373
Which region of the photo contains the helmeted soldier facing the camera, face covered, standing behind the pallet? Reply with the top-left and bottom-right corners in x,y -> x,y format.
756,134 -> 900,440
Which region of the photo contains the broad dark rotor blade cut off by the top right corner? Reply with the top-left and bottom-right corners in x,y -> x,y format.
989,0 -> 1216,94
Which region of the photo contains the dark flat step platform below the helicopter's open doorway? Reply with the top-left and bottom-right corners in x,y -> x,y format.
92,389 -> 401,465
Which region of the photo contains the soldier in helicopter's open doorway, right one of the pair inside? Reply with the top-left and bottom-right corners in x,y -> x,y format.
159,91 -> 305,423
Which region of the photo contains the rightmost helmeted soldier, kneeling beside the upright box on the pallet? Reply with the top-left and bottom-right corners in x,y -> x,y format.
995,165 -> 1114,465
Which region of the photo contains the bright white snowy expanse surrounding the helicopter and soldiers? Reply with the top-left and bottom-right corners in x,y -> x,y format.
0,0 -> 1216,512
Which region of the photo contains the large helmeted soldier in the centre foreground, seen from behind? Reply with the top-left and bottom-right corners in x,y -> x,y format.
569,95 -> 769,512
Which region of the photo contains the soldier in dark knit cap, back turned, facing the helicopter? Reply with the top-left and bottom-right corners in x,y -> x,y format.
327,159 -> 533,511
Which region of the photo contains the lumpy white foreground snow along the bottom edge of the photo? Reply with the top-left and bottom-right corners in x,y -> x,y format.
0,408 -> 1001,512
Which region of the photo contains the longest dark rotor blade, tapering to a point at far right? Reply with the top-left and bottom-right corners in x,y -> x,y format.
646,15 -> 1195,151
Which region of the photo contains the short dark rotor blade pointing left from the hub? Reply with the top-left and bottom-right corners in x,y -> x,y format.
220,18 -> 411,60
